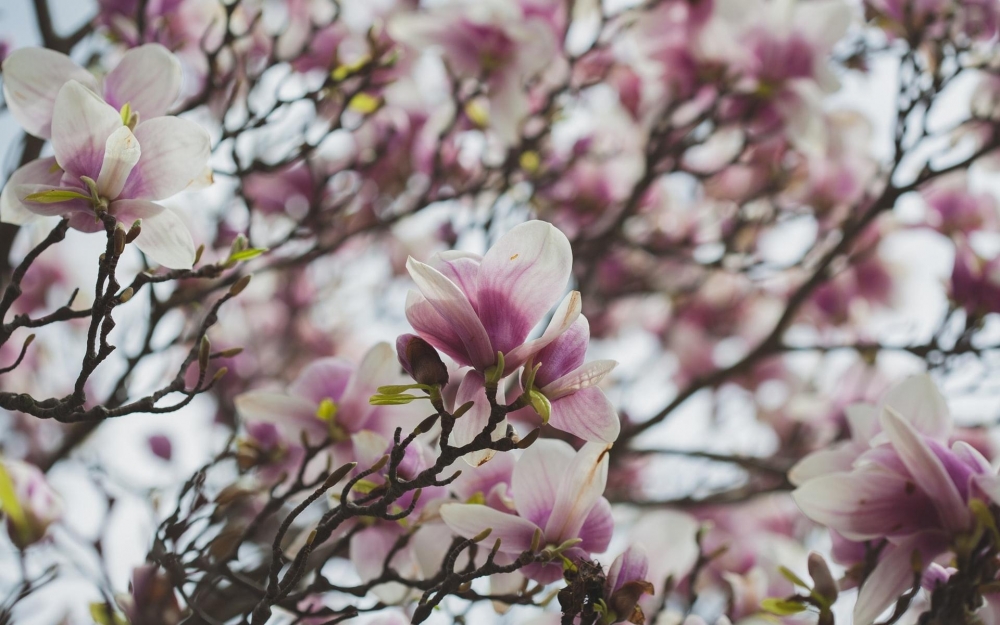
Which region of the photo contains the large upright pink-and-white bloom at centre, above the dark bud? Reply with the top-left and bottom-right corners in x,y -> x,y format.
406,221 -> 580,374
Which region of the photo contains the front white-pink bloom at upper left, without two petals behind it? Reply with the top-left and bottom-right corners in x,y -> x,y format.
0,80 -> 211,269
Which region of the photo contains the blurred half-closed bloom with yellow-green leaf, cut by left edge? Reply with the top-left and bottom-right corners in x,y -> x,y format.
0,460 -> 63,549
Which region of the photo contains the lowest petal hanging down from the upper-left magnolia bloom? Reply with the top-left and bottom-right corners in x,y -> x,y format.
111,200 -> 195,269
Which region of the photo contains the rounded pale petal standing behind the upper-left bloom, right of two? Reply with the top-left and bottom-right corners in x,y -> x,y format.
104,43 -> 181,122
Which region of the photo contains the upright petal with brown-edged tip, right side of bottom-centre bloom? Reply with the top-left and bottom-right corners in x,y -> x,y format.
545,443 -> 611,543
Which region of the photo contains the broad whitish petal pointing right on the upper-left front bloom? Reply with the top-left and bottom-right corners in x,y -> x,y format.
122,117 -> 212,200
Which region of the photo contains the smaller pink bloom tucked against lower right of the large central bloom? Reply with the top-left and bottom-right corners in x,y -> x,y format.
522,315 -> 621,443
